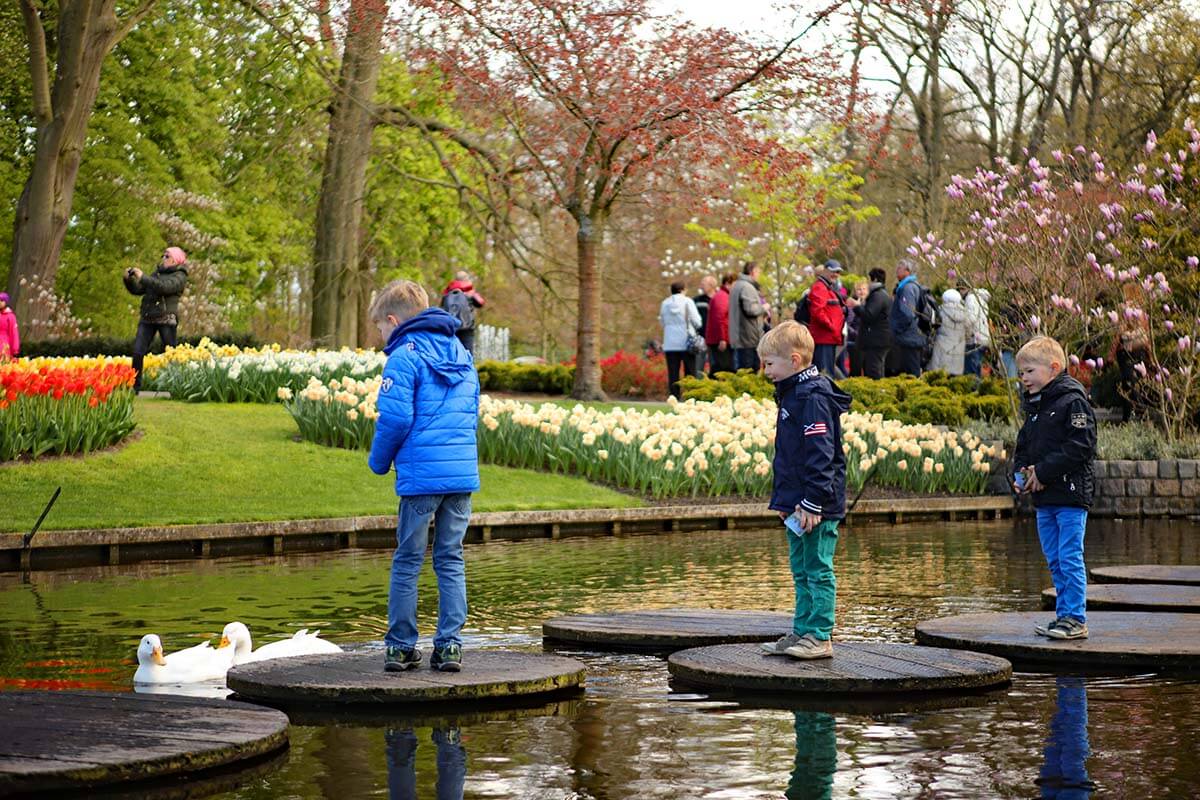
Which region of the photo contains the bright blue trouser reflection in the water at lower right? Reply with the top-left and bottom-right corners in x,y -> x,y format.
1036,676 -> 1096,800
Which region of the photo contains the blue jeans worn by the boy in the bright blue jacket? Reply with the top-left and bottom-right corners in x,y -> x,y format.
384,493 -> 470,650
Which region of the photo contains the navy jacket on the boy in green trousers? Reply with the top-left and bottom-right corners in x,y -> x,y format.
770,367 -> 850,519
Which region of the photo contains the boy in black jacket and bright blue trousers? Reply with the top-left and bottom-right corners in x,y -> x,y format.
1013,336 -> 1096,639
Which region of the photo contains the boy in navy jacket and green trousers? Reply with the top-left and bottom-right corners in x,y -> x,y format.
758,320 -> 850,660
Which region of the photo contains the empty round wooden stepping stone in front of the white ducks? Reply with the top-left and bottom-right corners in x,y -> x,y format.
0,692 -> 288,796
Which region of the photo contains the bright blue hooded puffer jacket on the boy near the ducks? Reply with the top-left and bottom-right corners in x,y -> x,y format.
367,308 -> 479,497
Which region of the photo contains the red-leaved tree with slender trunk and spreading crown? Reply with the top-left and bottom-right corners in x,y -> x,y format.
383,0 -> 848,399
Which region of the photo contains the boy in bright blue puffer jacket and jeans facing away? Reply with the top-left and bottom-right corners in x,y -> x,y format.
367,281 -> 479,672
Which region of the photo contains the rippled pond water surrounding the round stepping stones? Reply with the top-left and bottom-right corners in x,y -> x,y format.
0,521 -> 1200,800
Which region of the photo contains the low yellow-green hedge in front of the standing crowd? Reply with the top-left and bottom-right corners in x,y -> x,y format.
679,369 -> 1010,427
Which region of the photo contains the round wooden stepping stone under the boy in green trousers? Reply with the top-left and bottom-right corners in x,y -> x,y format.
667,642 -> 1013,694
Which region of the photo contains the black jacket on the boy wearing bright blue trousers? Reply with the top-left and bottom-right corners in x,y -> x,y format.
1013,373 -> 1096,509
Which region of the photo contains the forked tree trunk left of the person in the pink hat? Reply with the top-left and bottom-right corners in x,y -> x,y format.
8,0 -> 132,339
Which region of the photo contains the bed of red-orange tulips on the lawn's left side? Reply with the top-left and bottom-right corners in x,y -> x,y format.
0,359 -> 134,461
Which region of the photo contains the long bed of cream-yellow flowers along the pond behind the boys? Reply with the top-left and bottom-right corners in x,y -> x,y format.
278,378 -> 1006,498
